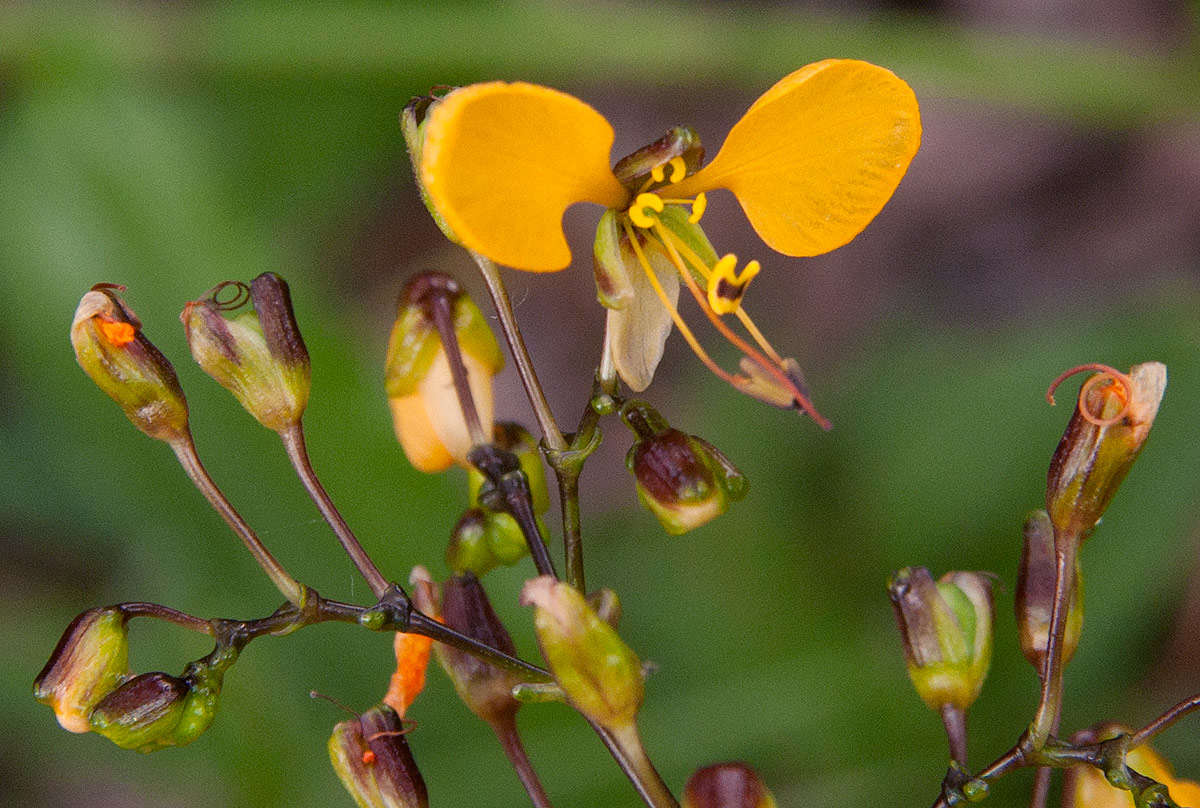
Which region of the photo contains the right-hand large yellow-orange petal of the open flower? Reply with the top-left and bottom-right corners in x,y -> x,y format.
671,59 -> 920,256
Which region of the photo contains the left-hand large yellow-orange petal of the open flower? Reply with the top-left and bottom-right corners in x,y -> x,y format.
420,82 -> 628,271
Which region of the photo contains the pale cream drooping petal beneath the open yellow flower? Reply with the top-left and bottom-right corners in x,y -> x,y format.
608,243 -> 679,393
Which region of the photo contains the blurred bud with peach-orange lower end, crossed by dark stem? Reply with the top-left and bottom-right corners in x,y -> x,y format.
386,273 -> 504,472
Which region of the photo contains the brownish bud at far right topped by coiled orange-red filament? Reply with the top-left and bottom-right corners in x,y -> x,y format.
1046,361 -> 1166,540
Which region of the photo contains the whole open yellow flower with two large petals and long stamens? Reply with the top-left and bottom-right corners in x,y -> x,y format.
419,59 -> 920,420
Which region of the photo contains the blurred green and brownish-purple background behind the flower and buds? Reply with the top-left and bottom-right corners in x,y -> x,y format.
0,0 -> 1200,808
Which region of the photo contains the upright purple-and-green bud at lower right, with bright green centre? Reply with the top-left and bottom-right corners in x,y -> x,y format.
888,567 -> 992,711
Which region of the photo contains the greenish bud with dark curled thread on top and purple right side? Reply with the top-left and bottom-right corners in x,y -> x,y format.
180,273 -> 312,431
